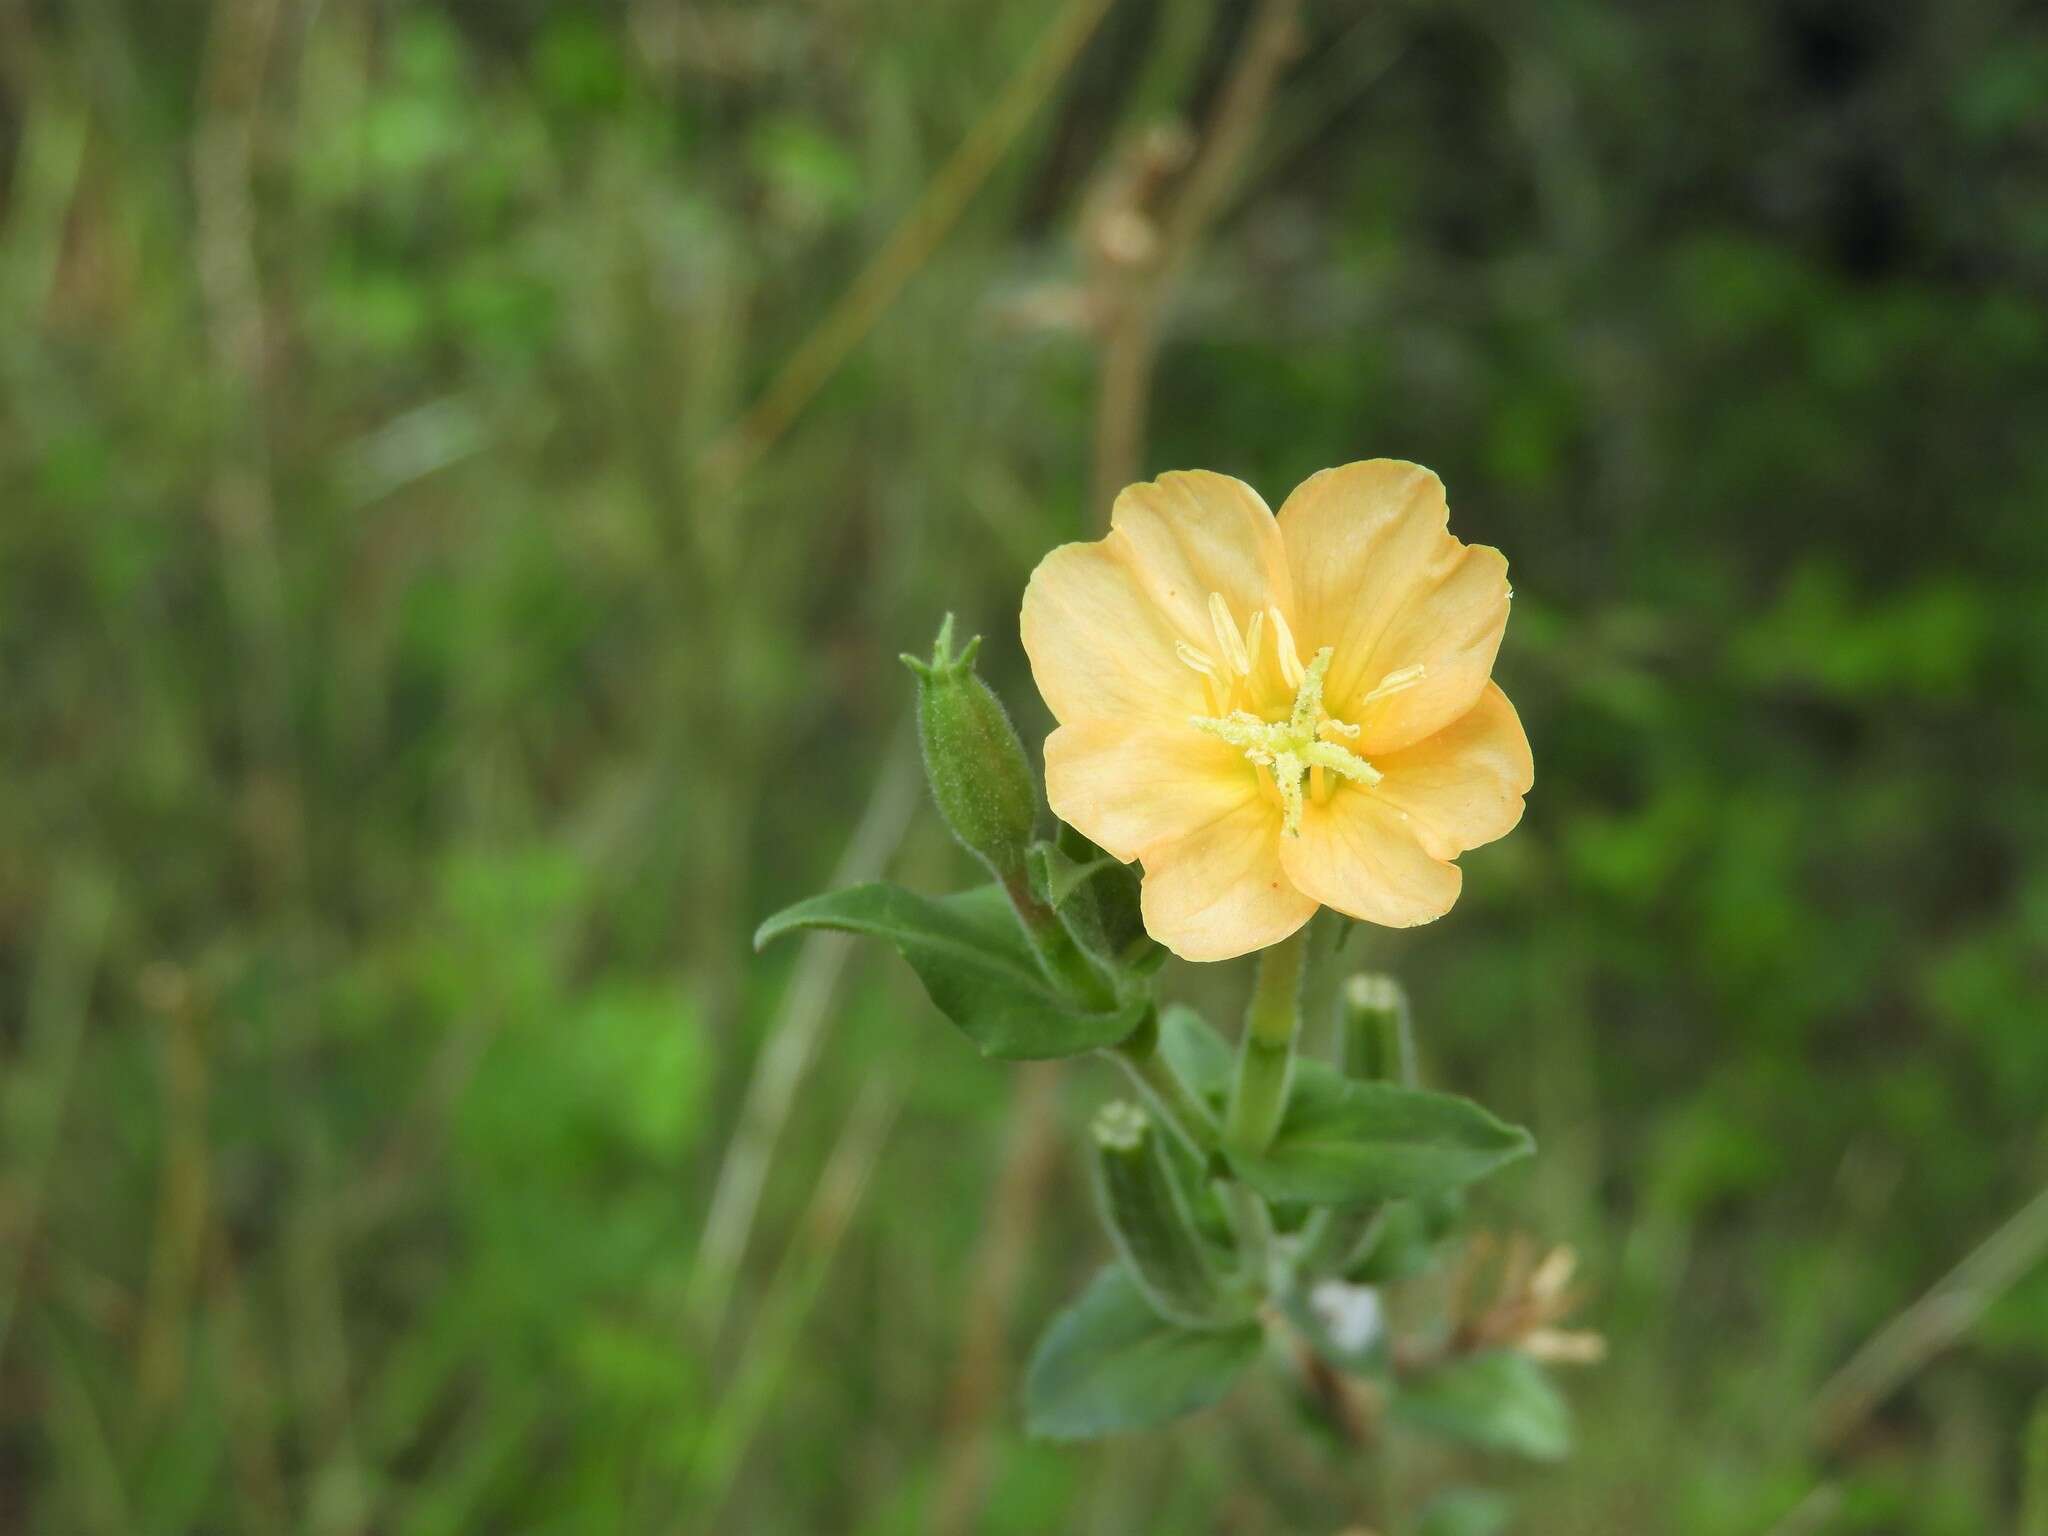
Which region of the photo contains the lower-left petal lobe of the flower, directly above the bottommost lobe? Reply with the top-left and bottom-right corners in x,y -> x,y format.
1044,719 -> 1260,862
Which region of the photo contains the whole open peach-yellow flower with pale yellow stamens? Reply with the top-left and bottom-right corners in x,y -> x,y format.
1024,459 -> 1534,961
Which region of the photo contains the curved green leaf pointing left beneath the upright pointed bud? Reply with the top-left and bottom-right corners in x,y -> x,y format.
754,885 -> 1145,1061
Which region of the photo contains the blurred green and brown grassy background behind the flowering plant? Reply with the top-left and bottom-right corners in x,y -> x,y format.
0,0 -> 2048,1536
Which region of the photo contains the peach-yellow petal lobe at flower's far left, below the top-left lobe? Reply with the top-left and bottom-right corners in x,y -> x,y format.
1022,541 -> 1208,725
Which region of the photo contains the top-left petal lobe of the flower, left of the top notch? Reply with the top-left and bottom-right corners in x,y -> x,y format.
1110,469 -> 1290,659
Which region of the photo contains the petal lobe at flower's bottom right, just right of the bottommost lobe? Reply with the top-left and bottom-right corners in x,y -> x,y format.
1280,786 -> 1464,928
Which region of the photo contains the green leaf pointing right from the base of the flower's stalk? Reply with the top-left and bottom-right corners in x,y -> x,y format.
1229,1061 -> 1536,1204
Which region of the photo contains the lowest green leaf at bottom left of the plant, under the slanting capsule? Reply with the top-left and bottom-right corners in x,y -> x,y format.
1024,1264 -> 1264,1440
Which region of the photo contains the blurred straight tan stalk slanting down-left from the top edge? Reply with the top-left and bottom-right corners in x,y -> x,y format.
705,0 -> 1114,489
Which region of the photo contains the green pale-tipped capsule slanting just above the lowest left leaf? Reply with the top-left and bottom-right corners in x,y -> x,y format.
1094,1100 -> 1235,1327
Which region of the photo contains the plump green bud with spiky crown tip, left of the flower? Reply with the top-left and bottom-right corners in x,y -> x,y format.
903,614 -> 1038,887
